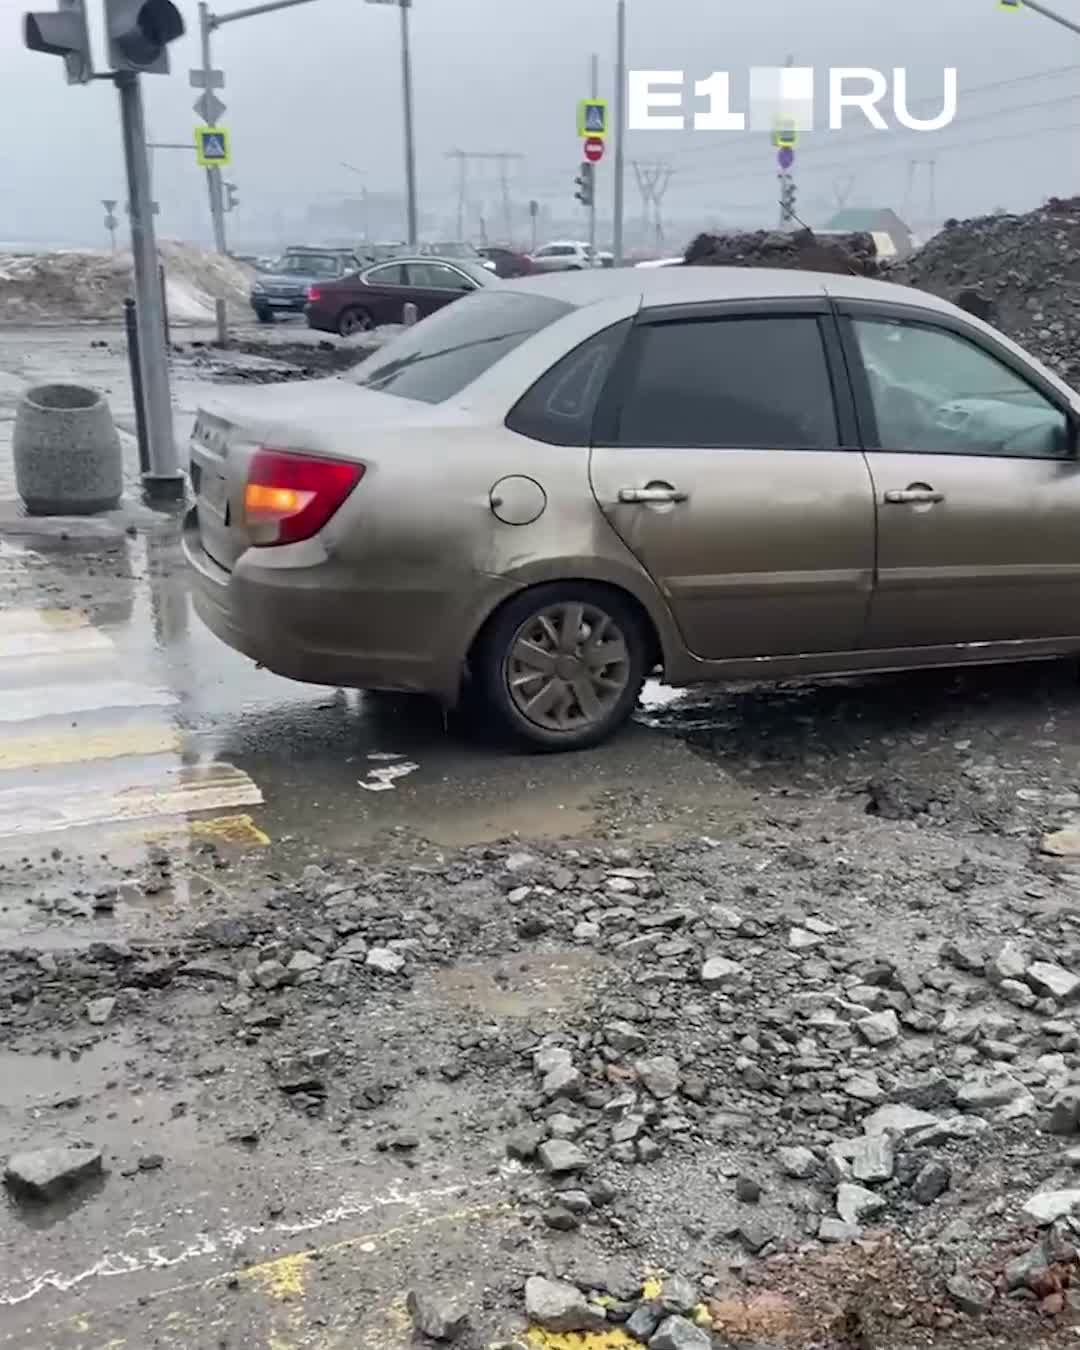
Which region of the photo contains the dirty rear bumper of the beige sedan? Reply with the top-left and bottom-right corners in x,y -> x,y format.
184,510 -> 513,706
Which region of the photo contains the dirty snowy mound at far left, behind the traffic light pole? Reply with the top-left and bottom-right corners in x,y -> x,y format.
0,240 -> 252,324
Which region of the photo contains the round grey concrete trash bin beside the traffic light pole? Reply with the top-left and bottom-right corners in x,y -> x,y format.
14,385 -> 124,516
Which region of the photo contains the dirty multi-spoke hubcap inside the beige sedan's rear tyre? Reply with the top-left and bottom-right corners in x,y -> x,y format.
505,601 -> 630,732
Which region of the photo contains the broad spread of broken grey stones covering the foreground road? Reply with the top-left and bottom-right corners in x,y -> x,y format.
10,810 -> 1080,1345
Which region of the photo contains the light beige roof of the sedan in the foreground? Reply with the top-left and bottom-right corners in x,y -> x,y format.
502,266 -> 960,313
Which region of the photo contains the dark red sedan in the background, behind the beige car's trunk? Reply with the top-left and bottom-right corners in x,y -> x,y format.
305,258 -> 498,338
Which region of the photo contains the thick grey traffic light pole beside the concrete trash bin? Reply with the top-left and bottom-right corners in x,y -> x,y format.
113,70 -> 184,501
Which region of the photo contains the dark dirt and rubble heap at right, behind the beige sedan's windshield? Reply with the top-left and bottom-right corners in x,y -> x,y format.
888,197 -> 1080,385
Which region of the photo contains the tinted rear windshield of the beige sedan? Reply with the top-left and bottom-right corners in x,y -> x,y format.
352,290 -> 574,404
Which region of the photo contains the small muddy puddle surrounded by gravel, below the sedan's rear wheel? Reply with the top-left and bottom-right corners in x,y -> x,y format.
423,948 -> 608,1018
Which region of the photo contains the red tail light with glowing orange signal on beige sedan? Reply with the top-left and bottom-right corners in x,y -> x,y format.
244,450 -> 363,547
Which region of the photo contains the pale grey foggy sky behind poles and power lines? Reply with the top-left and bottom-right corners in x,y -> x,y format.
0,0 -> 1080,246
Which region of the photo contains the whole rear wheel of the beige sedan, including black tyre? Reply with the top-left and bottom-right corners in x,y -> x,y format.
474,582 -> 647,751
